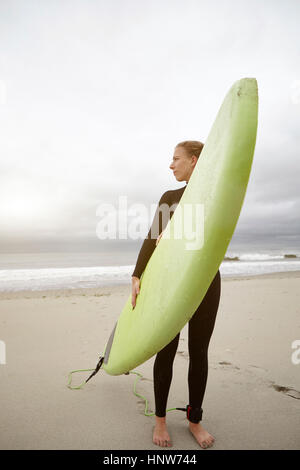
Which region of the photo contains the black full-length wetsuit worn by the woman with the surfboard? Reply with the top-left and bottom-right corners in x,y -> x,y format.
132,185 -> 221,423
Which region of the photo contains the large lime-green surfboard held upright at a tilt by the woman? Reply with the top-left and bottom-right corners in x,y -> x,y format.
102,78 -> 258,375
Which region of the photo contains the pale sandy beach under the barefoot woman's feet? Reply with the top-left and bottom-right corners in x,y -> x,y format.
0,272 -> 300,450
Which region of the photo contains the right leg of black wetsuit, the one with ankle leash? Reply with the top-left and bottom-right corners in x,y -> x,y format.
188,271 -> 221,414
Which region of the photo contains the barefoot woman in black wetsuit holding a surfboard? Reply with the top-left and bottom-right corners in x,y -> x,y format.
131,141 -> 221,448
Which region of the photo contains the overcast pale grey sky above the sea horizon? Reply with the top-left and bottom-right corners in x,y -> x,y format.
0,0 -> 300,253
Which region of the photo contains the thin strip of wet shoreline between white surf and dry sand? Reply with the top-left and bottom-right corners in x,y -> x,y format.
0,271 -> 300,300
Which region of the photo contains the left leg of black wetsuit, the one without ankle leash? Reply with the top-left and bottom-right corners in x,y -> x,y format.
153,333 -> 180,418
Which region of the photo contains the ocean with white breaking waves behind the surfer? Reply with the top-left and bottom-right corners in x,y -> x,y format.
0,250 -> 300,292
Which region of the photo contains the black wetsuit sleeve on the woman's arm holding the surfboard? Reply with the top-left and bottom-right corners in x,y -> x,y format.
132,191 -> 169,278
